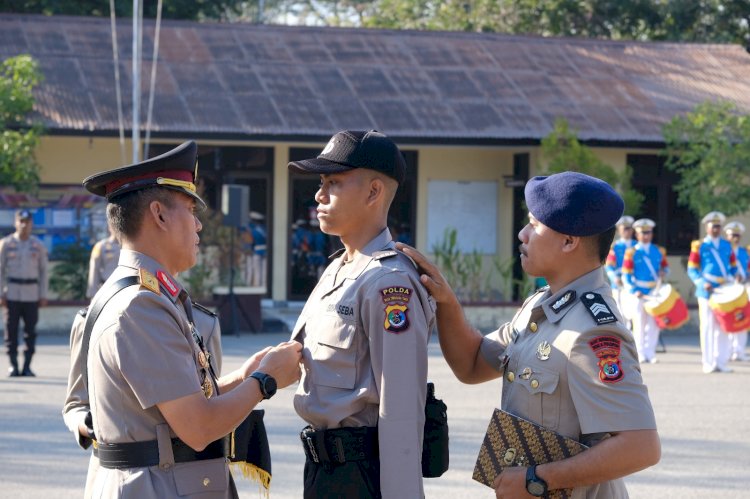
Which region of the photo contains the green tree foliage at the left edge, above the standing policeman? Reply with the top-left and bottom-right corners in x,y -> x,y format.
0,55 -> 42,191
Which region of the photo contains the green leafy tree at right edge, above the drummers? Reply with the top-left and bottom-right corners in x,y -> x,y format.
663,102 -> 750,217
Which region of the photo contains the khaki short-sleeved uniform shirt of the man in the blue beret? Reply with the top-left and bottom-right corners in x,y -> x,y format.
481,269 -> 656,499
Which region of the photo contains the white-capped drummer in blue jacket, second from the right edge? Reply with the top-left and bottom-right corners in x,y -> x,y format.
688,211 -> 737,374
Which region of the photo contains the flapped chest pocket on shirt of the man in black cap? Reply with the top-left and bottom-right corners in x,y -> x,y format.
305,315 -> 357,389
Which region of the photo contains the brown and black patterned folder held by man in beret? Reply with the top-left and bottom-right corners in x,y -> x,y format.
472,409 -> 588,499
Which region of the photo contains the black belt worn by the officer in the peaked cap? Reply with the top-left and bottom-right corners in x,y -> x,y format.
94,437 -> 229,470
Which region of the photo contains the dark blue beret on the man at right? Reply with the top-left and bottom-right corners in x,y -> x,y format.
524,172 -> 625,236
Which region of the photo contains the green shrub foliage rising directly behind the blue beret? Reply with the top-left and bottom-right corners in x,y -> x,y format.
541,118 -> 643,217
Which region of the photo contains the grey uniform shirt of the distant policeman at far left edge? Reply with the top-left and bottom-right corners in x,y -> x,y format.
0,233 -> 48,302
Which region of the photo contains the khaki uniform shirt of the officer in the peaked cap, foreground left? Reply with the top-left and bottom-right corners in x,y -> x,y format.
82,250 -> 234,499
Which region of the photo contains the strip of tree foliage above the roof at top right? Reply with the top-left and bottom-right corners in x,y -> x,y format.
362,0 -> 750,44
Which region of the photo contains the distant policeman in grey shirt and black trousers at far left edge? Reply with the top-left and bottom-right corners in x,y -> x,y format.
0,210 -> 48,376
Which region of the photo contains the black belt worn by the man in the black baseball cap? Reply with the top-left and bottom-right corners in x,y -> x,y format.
299,426 -> 379,465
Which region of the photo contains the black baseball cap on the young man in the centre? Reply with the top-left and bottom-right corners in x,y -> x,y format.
289,130 -> 406,184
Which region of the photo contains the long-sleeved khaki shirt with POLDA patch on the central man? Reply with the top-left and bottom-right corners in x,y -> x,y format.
292,229 -> 435,499
